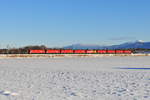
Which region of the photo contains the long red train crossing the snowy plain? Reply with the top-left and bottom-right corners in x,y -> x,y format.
28,49 -> 133,54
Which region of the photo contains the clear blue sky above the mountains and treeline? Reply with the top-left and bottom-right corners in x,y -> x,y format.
0,0 -> 150,47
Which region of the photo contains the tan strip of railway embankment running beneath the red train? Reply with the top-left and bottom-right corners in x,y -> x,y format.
0,54 -> 150,58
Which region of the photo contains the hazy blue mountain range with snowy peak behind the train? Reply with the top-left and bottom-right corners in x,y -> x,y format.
64,40 -> 150,49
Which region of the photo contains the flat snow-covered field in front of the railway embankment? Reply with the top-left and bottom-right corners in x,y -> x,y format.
0,56 -> 150,100
